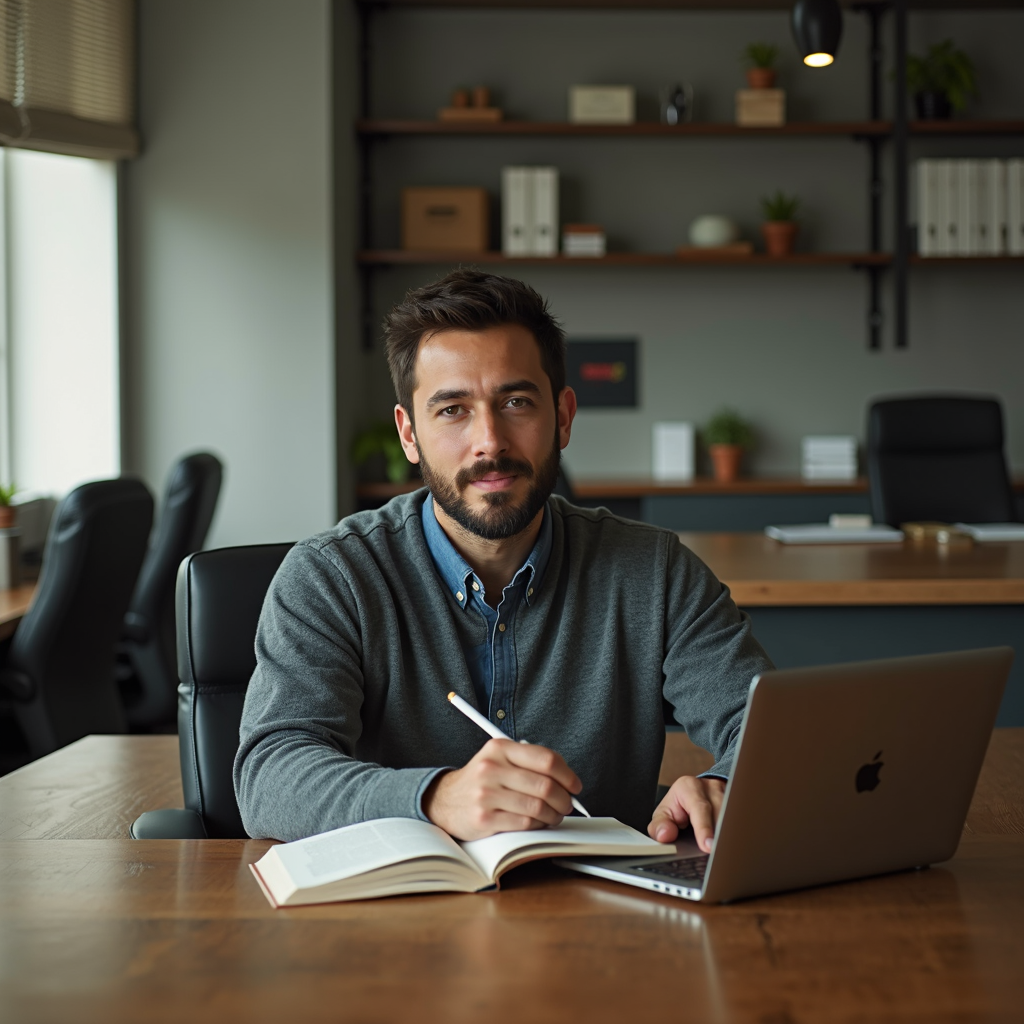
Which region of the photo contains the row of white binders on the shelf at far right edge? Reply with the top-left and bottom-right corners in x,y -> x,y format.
915,160 -> 1024,256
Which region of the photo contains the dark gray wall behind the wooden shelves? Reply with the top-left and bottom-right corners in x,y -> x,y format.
358,9 -> 1024,477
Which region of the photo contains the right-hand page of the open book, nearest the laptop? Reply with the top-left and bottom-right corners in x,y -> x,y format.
459,817 -> 675,881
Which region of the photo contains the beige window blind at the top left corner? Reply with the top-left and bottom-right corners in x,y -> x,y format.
0,0 -> 138,160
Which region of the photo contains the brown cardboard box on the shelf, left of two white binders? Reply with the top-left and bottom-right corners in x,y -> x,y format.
401,188 -> 489,252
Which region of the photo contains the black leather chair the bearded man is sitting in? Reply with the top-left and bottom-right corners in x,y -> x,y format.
131,544 -> 292,839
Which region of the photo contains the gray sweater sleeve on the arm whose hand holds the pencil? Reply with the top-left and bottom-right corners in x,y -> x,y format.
234,545 -> 440,840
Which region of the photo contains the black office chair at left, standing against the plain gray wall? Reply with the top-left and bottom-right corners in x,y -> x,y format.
118,452 -> 223,729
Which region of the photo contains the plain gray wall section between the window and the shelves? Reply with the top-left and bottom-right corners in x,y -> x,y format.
123,0 -> 337,546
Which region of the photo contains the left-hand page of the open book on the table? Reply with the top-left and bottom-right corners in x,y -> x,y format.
273,818 -> 481,889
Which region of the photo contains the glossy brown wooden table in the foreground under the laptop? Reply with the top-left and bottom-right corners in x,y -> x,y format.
0,730 -> 1024,1024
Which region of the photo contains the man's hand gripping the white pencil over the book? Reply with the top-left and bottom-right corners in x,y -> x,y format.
423,739 -> 583,840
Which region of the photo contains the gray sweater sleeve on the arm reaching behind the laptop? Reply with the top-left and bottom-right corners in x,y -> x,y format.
665,537 -> 772,777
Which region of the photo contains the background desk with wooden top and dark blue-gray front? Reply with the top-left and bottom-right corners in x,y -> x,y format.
679,534 -> 1024,726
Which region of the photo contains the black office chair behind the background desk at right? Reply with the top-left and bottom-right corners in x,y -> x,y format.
867,395 -> 1017,526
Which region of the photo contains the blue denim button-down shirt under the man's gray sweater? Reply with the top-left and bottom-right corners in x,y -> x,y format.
423,495 -> 551,739
